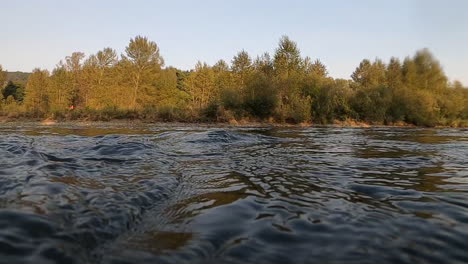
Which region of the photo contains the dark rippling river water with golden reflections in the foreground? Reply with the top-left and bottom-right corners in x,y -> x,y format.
0,124 -> 468,264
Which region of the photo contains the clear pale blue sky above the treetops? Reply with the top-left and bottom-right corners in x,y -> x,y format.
0,0 -> 468,85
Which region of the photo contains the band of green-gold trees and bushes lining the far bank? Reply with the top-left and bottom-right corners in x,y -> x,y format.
0,36 -> 468,126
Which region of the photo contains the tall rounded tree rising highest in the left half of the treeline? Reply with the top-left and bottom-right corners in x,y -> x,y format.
122,36 -> 164,109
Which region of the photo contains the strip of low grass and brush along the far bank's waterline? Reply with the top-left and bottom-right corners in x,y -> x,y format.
0,104 -> 468,127
